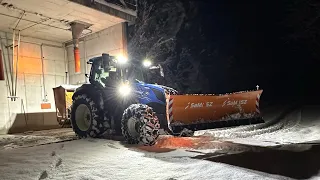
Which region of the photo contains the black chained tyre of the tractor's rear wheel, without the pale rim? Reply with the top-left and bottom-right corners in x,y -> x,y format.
71,94 -> 106,138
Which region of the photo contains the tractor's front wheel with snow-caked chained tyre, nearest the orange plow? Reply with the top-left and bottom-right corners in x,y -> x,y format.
121,104 -> 160,146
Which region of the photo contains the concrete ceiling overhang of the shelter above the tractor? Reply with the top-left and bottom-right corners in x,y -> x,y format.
0,0 -> 136,43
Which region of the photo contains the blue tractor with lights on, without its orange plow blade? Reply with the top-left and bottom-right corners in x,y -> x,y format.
71,54 -> 177,145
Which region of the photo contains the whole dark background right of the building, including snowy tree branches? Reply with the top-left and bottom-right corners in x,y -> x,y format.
129,0 -> 320,104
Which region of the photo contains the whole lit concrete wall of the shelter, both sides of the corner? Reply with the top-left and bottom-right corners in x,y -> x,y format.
0,24 -> 126,134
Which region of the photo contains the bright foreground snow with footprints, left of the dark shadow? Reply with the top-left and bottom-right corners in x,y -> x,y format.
0,139 -> 300,180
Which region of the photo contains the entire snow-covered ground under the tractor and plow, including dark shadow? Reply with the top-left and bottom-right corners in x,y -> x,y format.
0,106 -> 320,180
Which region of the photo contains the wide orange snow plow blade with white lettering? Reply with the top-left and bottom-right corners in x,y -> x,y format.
167,90 -> 264,133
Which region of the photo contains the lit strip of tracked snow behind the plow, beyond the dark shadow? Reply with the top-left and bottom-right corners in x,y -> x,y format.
195,106 -> 320,146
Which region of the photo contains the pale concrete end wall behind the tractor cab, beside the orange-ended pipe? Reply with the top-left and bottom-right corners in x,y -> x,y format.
66,23 -> 126,84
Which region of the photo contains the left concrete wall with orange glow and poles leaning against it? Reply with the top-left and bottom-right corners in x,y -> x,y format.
0,32 -> 67,134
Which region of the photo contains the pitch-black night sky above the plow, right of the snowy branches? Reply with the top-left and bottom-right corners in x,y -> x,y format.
130,0 -> 320,106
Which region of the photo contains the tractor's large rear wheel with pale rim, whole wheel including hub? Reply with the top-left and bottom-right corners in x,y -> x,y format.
71,94 -> 106,138
